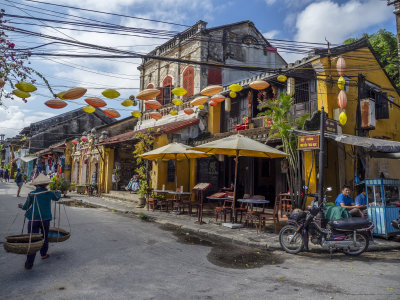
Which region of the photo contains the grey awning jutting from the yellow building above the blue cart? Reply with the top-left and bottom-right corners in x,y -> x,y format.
325,133 -> 400,153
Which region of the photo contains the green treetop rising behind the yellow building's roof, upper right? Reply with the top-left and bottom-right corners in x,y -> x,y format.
344,29 -> 400,88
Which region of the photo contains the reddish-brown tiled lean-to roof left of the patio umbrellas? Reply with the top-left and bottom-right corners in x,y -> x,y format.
98,118 -> 200,145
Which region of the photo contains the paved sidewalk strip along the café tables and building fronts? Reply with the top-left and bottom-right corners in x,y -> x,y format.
69,193 -> 400,251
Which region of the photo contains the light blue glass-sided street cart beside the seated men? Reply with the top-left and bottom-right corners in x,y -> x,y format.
364,178 -> 400,238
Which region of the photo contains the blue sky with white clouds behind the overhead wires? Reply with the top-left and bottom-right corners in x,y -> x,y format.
0,0 -> 396,137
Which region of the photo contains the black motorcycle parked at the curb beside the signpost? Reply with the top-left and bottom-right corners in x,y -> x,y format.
279,188 -> 374,257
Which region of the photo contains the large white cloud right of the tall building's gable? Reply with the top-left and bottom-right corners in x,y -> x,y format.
295,0 -> 394,43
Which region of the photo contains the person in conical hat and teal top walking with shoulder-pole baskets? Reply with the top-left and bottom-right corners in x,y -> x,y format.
18,174 -> 61,270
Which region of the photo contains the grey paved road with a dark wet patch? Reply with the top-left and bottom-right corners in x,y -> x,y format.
0,183 -> 400,299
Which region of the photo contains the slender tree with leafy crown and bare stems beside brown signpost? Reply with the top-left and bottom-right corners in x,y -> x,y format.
258,93 -> 309,209
